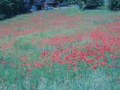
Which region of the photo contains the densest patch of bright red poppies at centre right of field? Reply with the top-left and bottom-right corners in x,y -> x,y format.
31,20 -> 120,71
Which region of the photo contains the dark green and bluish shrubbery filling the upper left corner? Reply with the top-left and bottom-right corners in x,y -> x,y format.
0,0 -> 45,18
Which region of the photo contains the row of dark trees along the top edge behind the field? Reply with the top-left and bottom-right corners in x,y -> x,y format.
0,0 -> 120,18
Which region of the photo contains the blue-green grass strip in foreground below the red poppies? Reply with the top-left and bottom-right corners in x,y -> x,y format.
0,61 -> 120,90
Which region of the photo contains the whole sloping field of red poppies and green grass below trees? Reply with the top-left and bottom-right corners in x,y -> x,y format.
0,7 -> 120,90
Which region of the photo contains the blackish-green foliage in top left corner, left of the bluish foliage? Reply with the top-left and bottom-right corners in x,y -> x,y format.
0,0 -> 25,18
